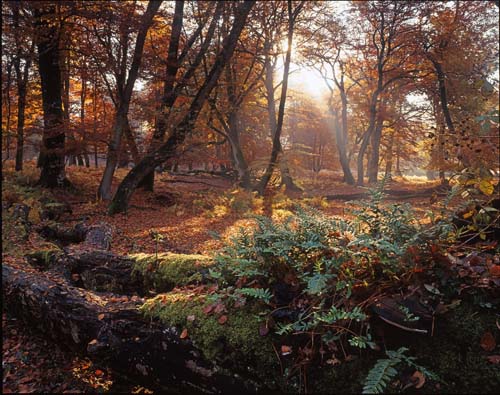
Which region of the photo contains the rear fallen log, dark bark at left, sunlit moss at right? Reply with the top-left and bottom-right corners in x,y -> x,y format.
26,249 -> 212,295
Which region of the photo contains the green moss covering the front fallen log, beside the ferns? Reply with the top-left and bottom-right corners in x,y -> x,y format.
141,291 -> 281,387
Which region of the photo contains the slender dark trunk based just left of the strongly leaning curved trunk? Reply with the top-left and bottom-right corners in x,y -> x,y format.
98,1 -> 162,200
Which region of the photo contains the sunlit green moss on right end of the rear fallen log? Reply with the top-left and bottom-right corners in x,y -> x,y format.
130,253 -> 213,292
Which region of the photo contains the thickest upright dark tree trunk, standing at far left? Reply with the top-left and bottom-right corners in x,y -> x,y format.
35,5 -> 69,188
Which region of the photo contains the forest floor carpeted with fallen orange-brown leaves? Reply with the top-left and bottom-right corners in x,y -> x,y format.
2,162 -> 492,393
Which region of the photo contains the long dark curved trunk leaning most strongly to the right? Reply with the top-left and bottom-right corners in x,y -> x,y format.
109,0 -> 255,214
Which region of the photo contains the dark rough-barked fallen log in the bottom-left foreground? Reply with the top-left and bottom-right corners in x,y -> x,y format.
2,265 -> 257,393
